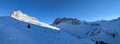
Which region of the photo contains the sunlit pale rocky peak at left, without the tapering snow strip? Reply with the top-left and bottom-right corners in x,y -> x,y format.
10,10 -> 39,22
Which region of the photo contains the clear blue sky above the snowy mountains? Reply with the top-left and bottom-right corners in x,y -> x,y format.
0,0 -> 120,24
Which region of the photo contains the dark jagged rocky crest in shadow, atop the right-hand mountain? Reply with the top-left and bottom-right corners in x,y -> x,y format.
53,17 -> 81,25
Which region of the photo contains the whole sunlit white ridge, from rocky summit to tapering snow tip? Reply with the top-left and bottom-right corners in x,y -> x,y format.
10,11 -> 60,30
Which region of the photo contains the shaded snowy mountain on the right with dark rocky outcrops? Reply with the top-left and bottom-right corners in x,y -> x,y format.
52,17 -> 120,44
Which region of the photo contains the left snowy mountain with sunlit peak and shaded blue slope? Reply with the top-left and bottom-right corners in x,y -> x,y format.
0,11 -> 95,44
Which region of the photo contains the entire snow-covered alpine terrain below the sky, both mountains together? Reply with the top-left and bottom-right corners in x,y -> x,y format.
0,11 -> 94,44
